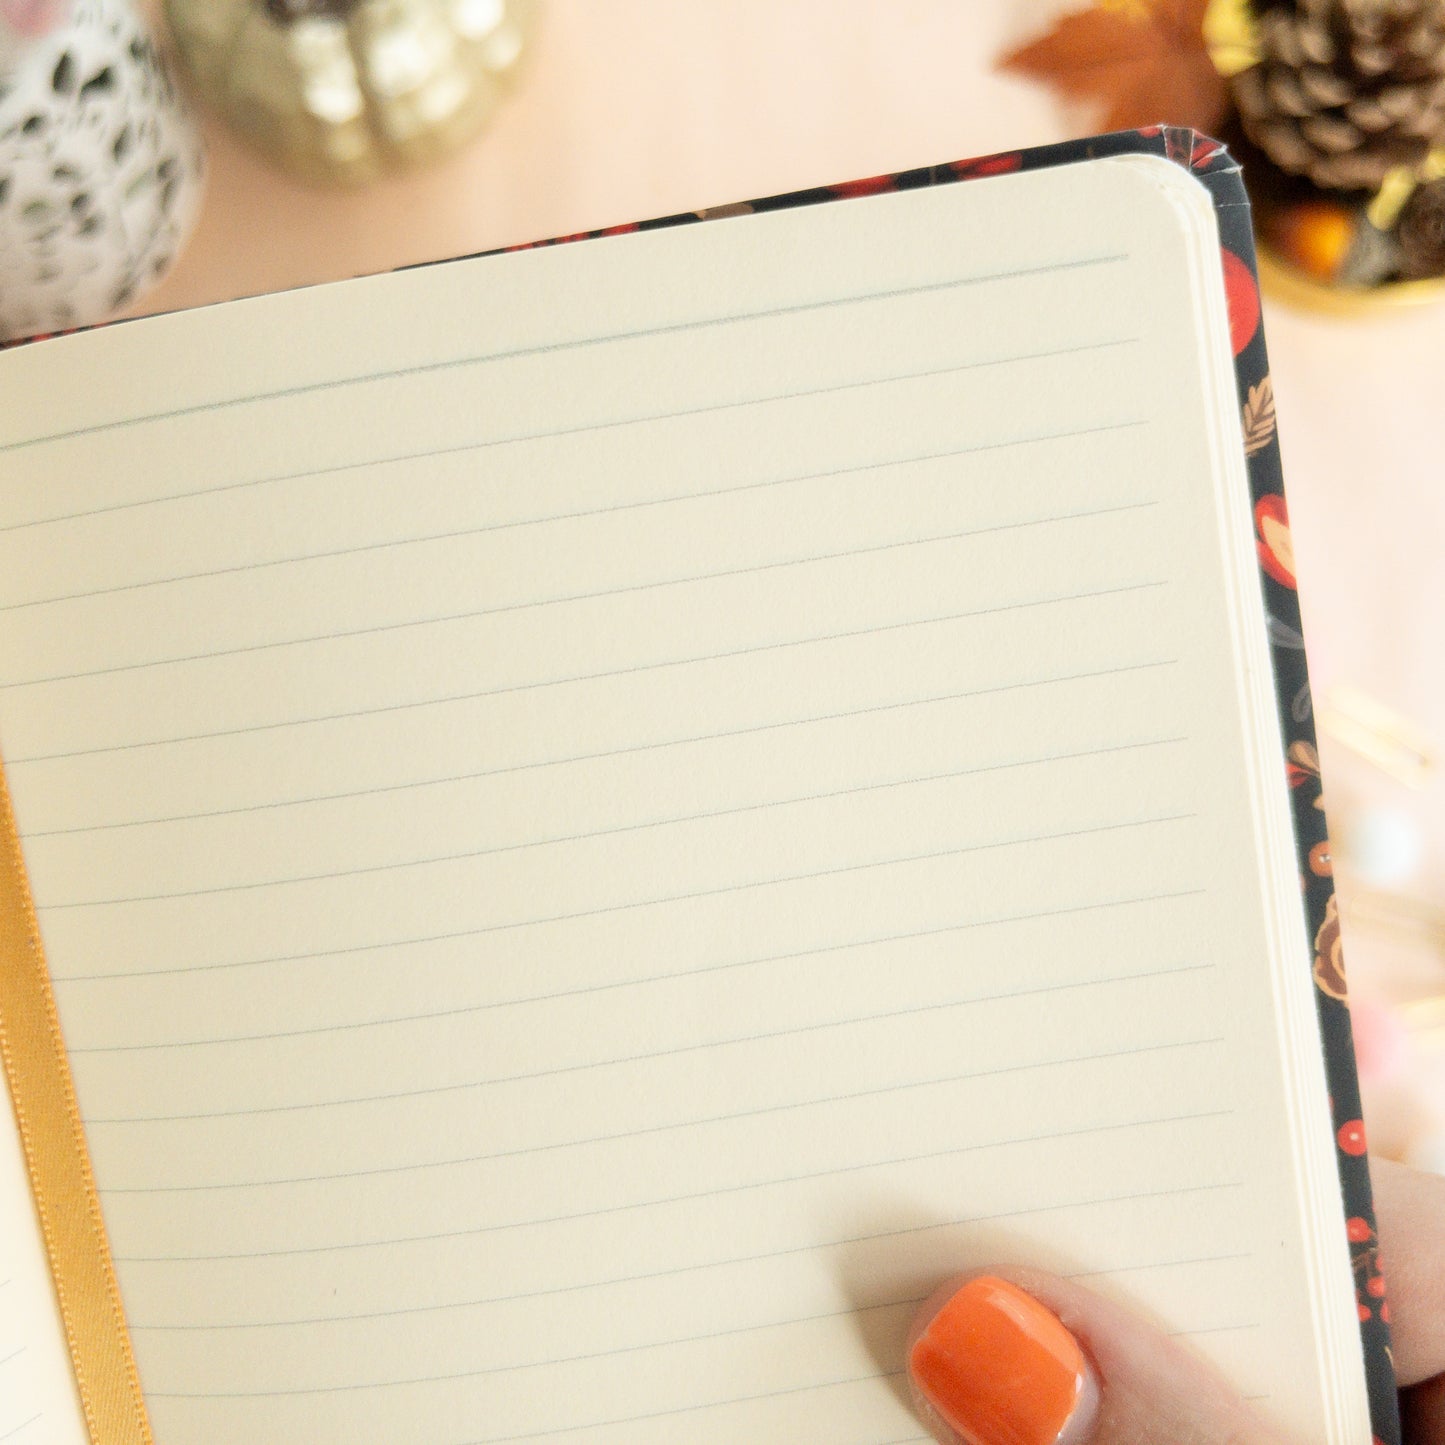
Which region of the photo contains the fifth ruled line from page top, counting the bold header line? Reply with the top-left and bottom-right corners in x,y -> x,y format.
8,578 -> 1172,772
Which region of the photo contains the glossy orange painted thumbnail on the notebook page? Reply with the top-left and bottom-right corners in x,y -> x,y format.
909,1274 -> 1091,1445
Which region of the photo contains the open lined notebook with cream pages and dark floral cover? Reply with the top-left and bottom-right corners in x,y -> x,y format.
0,131 -> 1390,1445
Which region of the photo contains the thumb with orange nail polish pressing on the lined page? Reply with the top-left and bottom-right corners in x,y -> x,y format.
907,1270 -> 1282,1445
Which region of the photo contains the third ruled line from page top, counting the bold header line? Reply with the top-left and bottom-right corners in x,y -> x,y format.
0,420 -> 1147,613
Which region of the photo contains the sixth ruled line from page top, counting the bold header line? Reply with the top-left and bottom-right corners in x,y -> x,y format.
22,657 -> 1179,838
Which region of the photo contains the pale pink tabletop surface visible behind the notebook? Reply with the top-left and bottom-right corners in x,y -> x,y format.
127,0 -> 1445,1152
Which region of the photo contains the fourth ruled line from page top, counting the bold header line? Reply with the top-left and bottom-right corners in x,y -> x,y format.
0,499 -> 1159,691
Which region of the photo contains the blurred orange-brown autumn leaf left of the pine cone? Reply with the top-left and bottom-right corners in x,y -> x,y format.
1000,0 -> 1225,131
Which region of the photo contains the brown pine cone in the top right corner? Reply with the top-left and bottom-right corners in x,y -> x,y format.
1234,0 -> 1445,191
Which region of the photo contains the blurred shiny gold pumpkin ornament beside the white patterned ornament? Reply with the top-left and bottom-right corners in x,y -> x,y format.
166,0 -> 535,185
